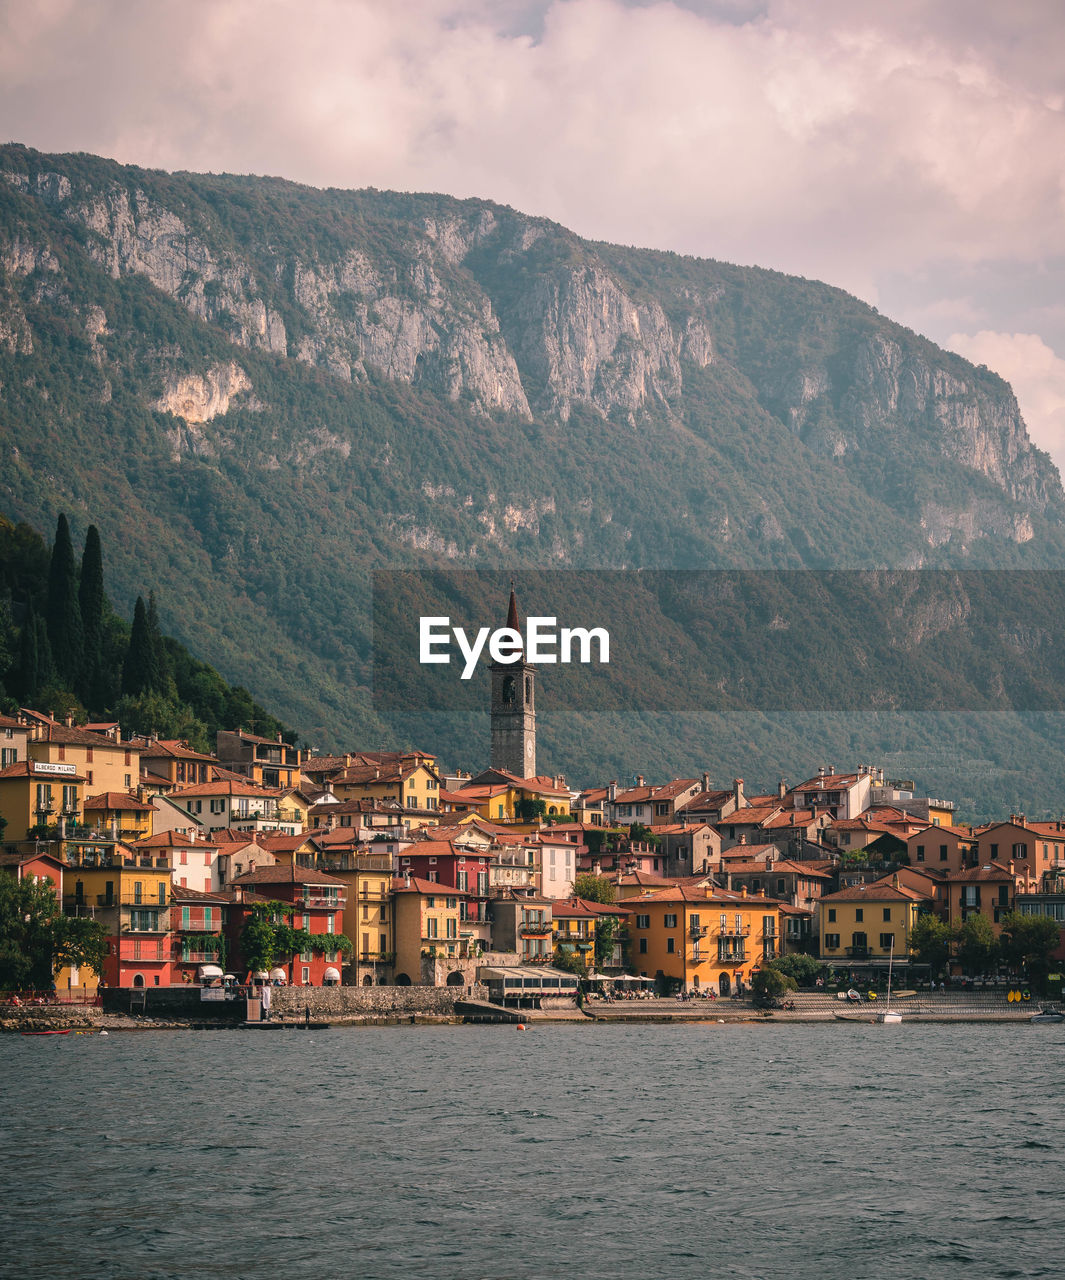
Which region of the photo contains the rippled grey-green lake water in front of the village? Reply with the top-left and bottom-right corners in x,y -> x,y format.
0,1024 -> 1065,1280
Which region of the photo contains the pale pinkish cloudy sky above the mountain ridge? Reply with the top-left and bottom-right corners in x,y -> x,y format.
0,0 -> 1065,470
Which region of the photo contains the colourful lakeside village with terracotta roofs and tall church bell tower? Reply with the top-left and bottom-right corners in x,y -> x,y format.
0,596 -> 1065,1002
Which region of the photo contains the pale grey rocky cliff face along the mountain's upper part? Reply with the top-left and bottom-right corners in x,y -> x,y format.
0,148 -> 1065,549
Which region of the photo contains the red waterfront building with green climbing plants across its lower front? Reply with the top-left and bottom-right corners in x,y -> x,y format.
225,863 -> 347,987
